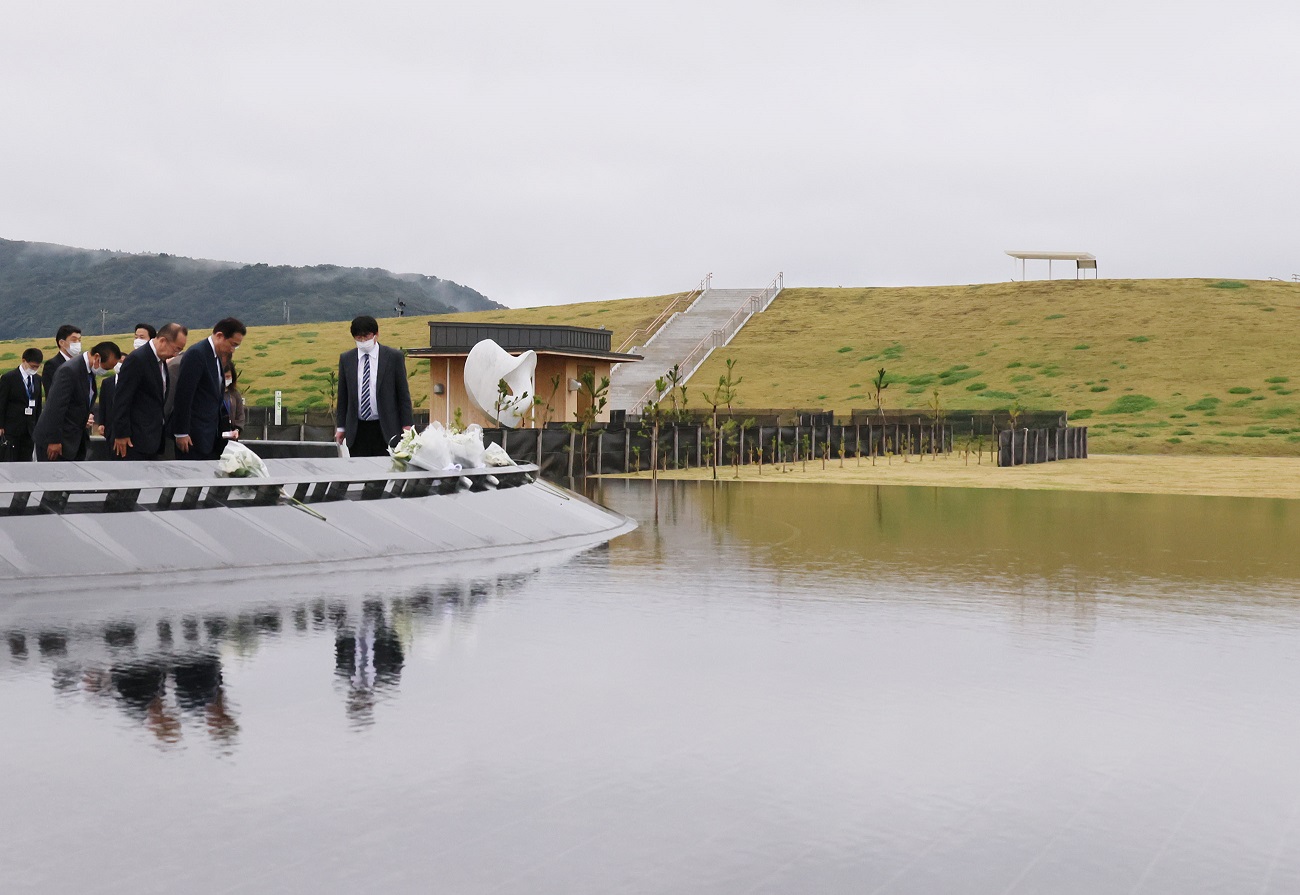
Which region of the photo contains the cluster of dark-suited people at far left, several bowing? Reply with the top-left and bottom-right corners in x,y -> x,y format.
0,317 -> 247,461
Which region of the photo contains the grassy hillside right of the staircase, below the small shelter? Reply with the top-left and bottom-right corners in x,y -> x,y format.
693,280 -> 1300,455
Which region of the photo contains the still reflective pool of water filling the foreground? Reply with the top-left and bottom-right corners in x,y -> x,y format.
0,483 -> 1300,892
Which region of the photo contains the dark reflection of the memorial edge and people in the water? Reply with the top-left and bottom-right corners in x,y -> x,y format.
0,570 -> 536,749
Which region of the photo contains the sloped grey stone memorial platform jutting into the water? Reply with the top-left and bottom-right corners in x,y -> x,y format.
0,458 -> 636,593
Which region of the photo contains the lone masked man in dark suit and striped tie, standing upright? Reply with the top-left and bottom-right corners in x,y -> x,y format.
334,316 -> 413,457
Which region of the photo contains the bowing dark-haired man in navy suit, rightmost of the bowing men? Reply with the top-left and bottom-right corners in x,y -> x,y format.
172,317 -> 248,461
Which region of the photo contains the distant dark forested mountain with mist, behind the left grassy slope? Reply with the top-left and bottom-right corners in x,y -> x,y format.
0,239 -> 504,338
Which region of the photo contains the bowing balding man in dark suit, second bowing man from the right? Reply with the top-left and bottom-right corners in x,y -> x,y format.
109,323 -> 190,461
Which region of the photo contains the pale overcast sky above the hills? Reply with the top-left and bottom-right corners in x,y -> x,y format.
0,0 -> 1300,306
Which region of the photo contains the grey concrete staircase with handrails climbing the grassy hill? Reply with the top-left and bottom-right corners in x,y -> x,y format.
610,274 -> 781,414
